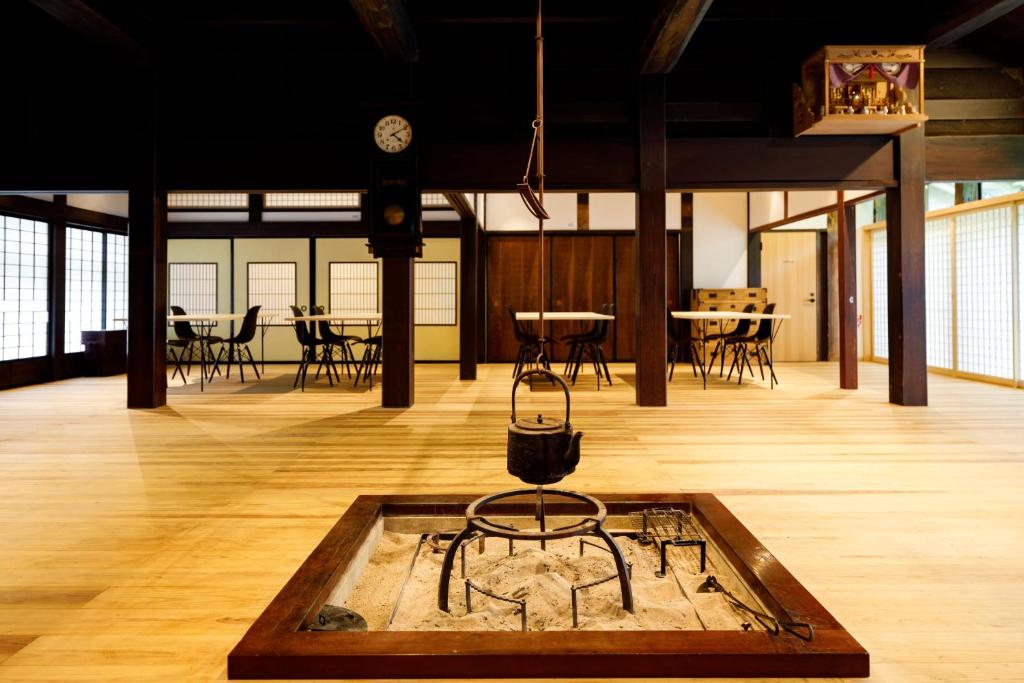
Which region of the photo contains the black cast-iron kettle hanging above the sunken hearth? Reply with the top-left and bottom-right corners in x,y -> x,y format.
508,369 -> 583,485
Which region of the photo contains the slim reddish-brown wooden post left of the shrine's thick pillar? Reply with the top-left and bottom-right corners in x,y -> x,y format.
836,189 -> 857,389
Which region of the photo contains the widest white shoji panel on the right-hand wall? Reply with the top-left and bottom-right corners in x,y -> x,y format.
956,206 -> 1014,379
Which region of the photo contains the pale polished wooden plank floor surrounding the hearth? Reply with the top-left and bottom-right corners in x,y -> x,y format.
0,364 -> 1024,683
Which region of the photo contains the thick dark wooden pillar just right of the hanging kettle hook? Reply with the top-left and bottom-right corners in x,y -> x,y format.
636,74 -> 669,405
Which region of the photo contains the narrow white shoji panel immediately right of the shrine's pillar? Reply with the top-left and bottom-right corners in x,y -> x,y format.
925,217 -> 953,370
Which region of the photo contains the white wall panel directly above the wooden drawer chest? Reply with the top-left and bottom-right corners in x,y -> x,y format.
693,193 -> 749,289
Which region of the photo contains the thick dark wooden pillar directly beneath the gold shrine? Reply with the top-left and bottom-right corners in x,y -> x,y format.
886,127 -> 928,405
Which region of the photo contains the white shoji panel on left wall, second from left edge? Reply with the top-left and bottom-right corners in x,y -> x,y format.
65,227 -> 103,353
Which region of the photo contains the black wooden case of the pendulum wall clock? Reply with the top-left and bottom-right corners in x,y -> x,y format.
367,111 -> 423,257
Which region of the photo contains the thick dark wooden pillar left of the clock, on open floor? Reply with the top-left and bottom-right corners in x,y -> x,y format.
128,80 -> 167,408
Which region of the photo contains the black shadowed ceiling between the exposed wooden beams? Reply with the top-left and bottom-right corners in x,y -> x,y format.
0,0 -> 1024,152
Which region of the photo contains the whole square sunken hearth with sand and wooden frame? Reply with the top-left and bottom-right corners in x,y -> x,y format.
228,489 -> 868,679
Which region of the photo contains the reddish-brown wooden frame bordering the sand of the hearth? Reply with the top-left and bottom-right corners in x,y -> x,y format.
227,494 -> 869,679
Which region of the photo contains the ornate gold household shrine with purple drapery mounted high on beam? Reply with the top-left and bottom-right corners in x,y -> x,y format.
793,45 -> 928,136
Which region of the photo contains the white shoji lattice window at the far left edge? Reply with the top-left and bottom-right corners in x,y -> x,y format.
0,215 -> 50,360
